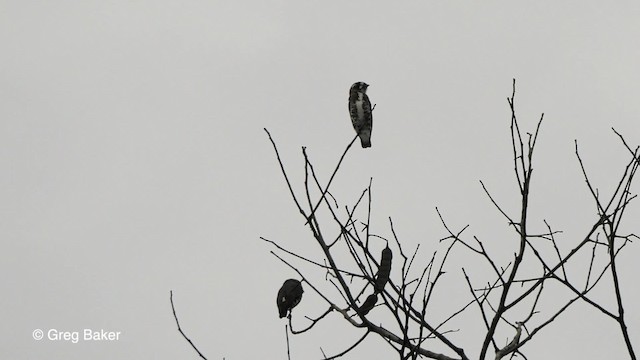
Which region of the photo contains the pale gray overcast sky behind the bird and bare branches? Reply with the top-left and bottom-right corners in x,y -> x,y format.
0,0 -> 640,359
